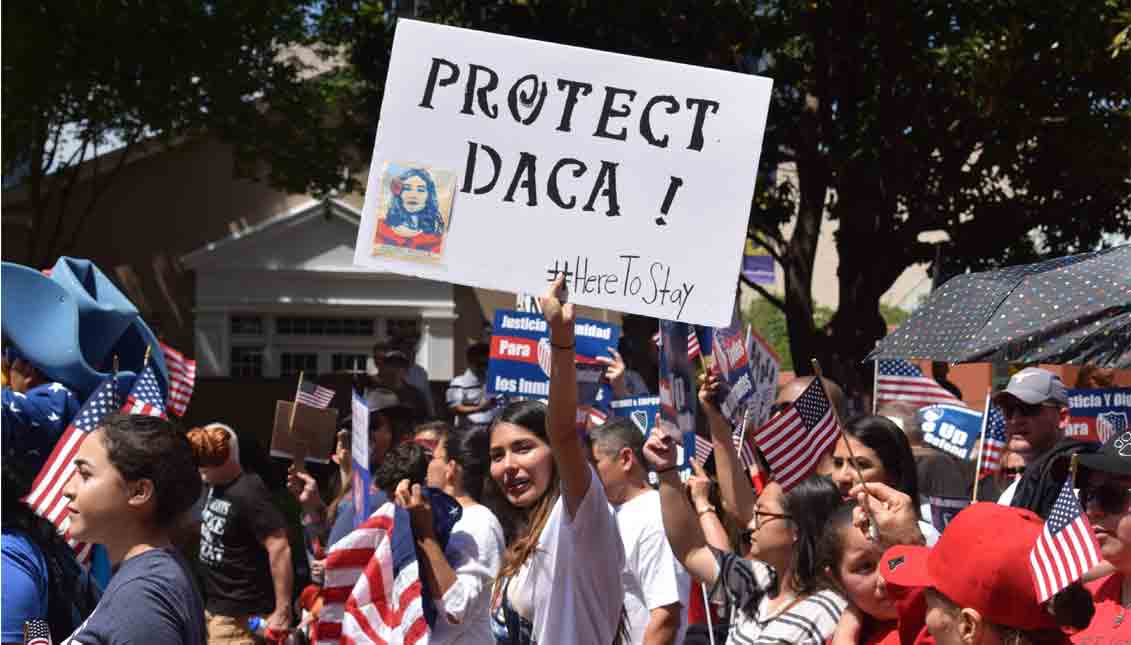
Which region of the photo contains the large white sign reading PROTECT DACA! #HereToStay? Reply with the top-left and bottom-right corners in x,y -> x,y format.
354,19 -> 772,326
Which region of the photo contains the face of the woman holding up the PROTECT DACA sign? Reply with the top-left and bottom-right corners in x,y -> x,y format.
491,423 -> 554,508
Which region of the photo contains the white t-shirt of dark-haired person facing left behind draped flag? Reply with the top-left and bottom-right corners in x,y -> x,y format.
430,505 -> 504,645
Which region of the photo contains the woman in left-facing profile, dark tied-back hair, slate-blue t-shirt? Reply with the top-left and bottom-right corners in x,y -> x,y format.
63,414 -> 206,645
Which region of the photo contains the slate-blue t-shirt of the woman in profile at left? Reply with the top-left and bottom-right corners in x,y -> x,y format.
61,549 -> 206,645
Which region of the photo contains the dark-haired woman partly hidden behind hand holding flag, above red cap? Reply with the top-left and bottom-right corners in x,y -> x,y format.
818,414 -> 939,547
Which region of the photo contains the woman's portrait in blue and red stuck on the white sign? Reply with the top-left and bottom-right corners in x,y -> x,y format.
373,162 -> 456,263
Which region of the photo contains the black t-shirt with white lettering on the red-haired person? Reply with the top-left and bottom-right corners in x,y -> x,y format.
200,473 -> 290,616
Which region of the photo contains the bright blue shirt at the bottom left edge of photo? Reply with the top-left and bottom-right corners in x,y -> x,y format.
0,529 -> 48,643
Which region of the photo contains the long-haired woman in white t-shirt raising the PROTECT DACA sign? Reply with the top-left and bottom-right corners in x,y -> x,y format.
490,275 -> 624,645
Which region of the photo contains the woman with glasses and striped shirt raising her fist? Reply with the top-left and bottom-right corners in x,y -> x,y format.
644,407 -> 846,645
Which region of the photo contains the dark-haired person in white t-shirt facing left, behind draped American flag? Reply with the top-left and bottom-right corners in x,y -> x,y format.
396,428 -> 503,645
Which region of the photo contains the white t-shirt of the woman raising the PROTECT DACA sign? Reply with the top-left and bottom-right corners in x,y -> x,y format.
507,466 -> 624,645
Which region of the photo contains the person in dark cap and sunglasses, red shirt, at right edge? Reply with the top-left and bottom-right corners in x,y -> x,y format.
1072,423 -> 1131,645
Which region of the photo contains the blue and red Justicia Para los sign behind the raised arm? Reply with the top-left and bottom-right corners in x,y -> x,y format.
487,309 -> 621,402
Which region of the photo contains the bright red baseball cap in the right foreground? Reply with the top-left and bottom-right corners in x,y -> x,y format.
880,502 -> 1057,630
